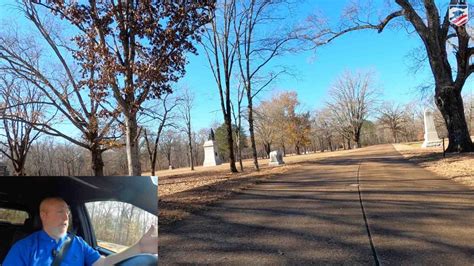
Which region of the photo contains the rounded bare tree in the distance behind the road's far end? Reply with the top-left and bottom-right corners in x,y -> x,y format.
327,72 -> 376,148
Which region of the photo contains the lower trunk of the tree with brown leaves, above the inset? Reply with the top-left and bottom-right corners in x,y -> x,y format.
125,113 -> 142,176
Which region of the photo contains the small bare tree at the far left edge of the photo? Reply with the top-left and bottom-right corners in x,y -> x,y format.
0,76 -> 45,176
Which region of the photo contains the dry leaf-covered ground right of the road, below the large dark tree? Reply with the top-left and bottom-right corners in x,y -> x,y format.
393,142 -> 474,188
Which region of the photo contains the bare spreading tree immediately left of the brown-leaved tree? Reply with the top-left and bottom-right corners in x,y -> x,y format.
0,4 -> 119,176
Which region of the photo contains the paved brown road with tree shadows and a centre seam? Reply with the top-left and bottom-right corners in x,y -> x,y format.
159,145 -> 474,266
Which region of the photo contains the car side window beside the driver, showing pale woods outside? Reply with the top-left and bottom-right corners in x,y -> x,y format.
86,201 -> 158,252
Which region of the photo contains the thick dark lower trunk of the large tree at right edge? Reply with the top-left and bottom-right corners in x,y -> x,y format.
435,86 -> 474,152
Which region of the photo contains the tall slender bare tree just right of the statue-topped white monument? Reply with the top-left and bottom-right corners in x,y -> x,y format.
201,0 -> 239,173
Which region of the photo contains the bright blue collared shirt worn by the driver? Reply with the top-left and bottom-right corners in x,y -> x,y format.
3,230 -> 100,266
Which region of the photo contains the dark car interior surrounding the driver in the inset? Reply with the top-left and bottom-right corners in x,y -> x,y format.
0,177 -> 158,265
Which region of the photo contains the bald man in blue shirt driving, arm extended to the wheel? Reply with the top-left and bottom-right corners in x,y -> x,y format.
3,198 -> 158,266
